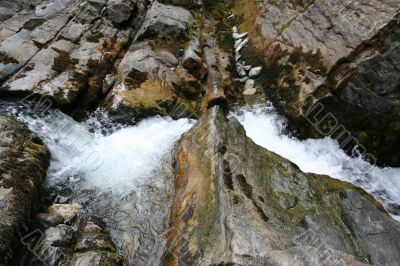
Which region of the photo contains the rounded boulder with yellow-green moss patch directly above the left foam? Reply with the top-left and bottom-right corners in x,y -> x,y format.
105,42 -> 197,122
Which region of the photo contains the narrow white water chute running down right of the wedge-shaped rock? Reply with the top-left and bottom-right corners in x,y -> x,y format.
232,106 -> 400,220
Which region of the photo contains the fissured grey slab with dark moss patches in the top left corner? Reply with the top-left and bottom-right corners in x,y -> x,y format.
0,0 -> 137,119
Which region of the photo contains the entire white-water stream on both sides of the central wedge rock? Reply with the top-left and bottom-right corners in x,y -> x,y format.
0,96 -> 400,265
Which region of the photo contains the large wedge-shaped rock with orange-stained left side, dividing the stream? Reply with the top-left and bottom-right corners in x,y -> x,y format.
164,106 -> 400,265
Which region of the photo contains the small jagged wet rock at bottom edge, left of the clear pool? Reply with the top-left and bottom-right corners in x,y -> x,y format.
29,212 -> 123,266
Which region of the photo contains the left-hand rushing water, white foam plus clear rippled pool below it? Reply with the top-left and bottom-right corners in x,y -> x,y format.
0,101 -> 194,265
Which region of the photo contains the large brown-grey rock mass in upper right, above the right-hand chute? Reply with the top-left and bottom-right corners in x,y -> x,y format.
234,0 -> 400,166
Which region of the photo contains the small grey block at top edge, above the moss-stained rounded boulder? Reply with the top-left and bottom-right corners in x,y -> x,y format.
136,2 -> 193,41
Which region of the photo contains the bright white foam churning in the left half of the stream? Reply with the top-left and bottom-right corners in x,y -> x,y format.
10,106 -> 194,192
